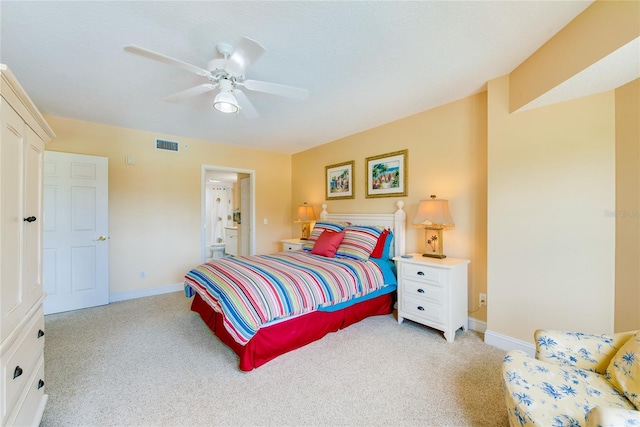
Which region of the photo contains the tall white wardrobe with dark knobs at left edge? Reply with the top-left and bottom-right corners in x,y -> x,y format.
0,64 -> 55,426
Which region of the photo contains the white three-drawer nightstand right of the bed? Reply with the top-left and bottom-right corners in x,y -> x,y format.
394,254 -> 470,342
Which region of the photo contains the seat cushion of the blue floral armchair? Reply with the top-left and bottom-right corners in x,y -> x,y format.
502,351 -> 635,426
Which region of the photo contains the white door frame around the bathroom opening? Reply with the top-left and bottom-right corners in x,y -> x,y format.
200,165 -> 256,263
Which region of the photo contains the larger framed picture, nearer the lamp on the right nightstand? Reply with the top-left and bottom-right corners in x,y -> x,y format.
366,150 -> 409,198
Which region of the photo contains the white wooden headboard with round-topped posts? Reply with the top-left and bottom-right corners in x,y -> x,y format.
320,200 -> 407,256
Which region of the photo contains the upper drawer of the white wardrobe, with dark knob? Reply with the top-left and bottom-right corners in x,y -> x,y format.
0,306 -> 44,420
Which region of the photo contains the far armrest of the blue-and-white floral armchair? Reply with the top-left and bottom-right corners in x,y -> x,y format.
534,329 -> 636,375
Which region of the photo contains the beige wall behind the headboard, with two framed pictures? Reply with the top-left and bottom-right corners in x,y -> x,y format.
290,92 -> 487,320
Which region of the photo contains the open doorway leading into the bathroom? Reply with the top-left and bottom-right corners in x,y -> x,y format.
201,165 -> 255,262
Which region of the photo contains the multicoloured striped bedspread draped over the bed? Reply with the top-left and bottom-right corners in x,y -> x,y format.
185,252 -> 384,345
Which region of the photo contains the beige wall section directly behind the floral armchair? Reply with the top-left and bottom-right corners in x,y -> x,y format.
487,76 -> 615,342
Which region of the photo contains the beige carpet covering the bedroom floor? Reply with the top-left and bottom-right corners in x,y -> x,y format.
42,292 -> 508,427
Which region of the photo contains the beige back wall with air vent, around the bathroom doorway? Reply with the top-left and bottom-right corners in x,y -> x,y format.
46,116 -> 291,293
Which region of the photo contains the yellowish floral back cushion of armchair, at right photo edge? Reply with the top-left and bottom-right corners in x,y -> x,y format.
607,331 -> 640,410
